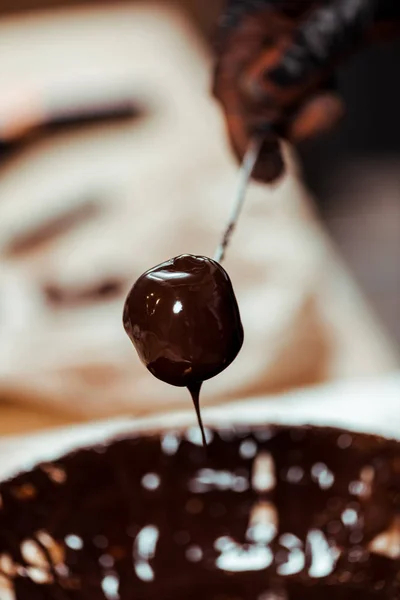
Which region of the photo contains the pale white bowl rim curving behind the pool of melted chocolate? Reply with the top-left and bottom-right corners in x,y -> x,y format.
0,374 -> 400,481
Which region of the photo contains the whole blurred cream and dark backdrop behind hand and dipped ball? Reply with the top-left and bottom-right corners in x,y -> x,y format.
0,0 -> 400,433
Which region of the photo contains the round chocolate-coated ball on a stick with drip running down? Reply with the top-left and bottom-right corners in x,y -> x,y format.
123,254 -> 243,440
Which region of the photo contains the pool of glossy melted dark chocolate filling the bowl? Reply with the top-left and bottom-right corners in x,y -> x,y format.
0,427 -> 400,600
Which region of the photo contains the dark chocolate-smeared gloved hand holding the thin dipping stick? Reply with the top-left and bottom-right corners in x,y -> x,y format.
214,0 -> 400,182
